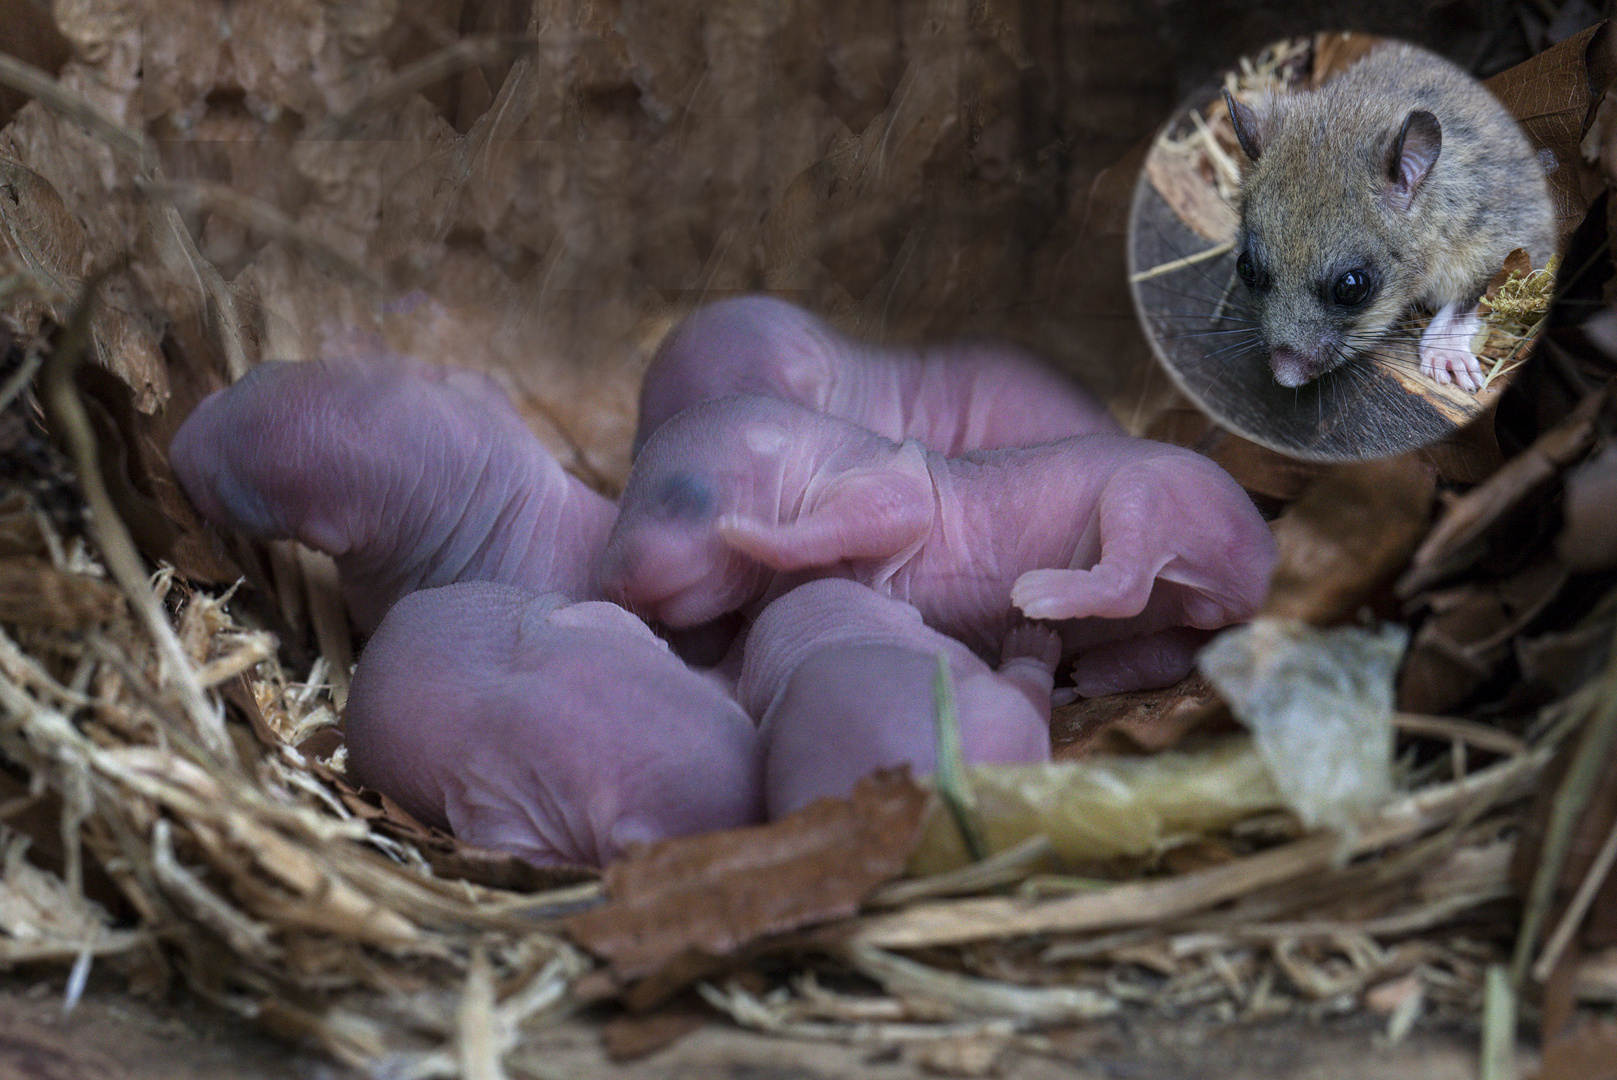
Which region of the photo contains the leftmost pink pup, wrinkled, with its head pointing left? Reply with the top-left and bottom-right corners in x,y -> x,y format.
170,352 -> 616,632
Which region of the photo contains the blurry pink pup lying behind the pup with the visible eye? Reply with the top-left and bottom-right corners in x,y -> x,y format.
634,296 -> 1122,454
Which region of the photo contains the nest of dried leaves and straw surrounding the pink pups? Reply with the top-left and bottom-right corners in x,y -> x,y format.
0,0 -> 1617,1077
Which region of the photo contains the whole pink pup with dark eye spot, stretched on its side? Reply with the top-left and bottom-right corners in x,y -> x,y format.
602,396 -> 1274,695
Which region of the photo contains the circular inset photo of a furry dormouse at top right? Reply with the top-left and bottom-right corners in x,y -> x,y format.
1129,34 -> 1556,461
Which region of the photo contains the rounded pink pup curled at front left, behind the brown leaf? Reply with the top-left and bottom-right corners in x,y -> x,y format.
344,582 -> 763,865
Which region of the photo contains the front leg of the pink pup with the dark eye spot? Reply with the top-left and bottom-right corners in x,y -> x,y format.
718,443 -> 936,577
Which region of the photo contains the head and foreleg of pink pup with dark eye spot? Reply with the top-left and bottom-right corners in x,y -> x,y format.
602,394 -> 936,627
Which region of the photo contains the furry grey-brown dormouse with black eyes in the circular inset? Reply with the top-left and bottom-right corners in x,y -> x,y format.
1224,44 -> 1556,391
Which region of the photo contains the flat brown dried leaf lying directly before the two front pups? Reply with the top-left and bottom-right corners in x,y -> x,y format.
566,773 -> 928,980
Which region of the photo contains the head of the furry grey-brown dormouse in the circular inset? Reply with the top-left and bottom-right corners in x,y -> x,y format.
1224,91 -> 1442,386
